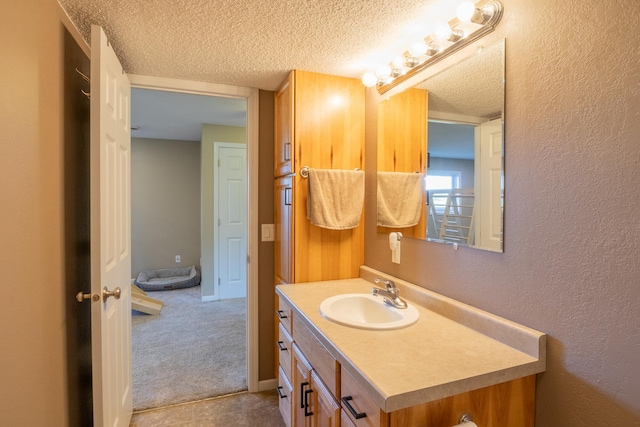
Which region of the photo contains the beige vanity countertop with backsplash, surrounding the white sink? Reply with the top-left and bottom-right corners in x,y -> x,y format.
276,267 -> 546,412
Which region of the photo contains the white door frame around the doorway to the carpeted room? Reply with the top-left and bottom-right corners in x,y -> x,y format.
128,74 -> 260,393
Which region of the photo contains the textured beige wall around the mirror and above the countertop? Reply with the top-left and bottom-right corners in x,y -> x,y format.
365,0 -> 640,427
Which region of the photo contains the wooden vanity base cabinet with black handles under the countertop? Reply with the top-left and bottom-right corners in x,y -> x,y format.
276,299 -> 536,427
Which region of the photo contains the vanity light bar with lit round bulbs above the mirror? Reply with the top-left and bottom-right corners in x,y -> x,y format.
362,0 -> 503,94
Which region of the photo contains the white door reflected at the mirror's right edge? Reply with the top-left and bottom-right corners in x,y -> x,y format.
474,119 -> 502,251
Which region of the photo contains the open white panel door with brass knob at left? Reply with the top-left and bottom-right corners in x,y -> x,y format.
91,25 -> 132,427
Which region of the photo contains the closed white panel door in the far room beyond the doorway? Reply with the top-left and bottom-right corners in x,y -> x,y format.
214,142 -> 247,299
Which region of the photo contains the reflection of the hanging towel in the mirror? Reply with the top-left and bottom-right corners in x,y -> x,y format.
378,172 -> 424,228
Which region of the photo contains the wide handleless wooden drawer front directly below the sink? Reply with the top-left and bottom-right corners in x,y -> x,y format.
293,319 -> 340,396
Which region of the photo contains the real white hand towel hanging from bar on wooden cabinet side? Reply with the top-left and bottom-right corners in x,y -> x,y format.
307,168 -> 364,230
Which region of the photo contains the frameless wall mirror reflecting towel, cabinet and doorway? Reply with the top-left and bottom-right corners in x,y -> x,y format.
377,40 -> 505,252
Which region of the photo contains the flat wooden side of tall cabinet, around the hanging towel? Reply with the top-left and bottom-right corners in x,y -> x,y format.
294,70 -> 365,283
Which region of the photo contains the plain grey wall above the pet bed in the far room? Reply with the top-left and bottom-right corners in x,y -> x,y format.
131,138 -> 200,277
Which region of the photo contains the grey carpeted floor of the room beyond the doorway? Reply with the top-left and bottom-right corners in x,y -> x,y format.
131,286 -> 247,411
